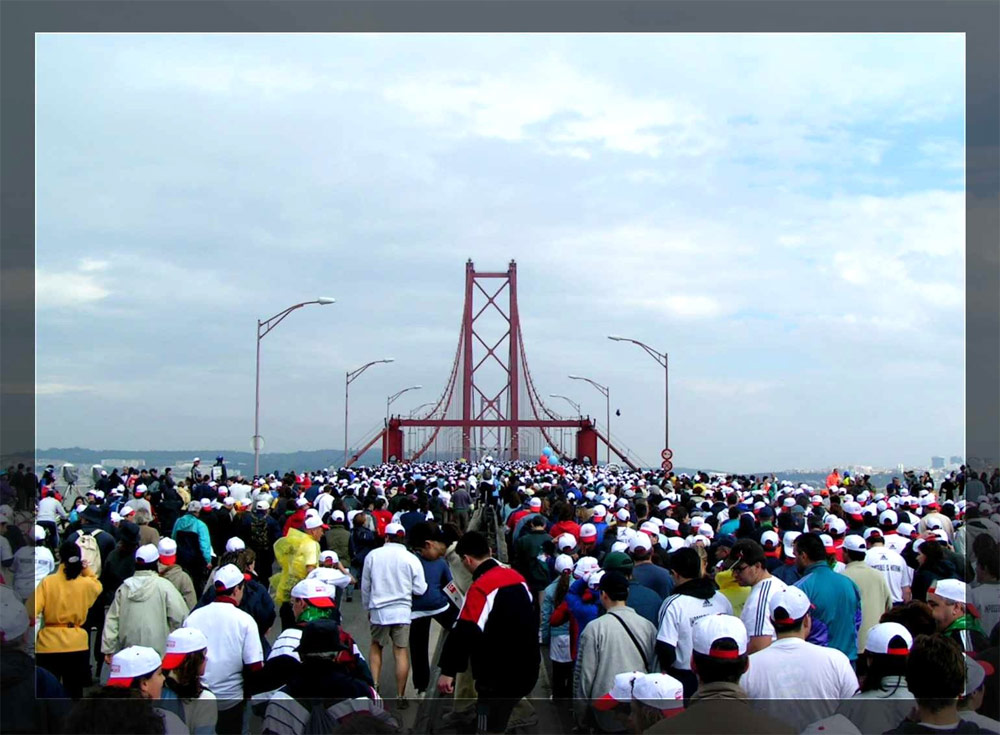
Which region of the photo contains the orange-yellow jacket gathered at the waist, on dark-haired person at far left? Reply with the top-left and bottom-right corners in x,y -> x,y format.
25,565 -> 102,653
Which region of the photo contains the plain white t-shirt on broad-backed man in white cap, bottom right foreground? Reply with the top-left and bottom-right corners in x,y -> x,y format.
740,638 -> 858,732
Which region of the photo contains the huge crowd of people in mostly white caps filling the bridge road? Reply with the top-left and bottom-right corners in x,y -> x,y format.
0,457 -> 1000,735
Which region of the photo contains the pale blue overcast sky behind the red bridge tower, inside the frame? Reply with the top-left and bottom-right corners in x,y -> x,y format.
36,34 -> 965,471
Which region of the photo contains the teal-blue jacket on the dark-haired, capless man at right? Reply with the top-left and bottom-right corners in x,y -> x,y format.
795,561 -> 861,661
